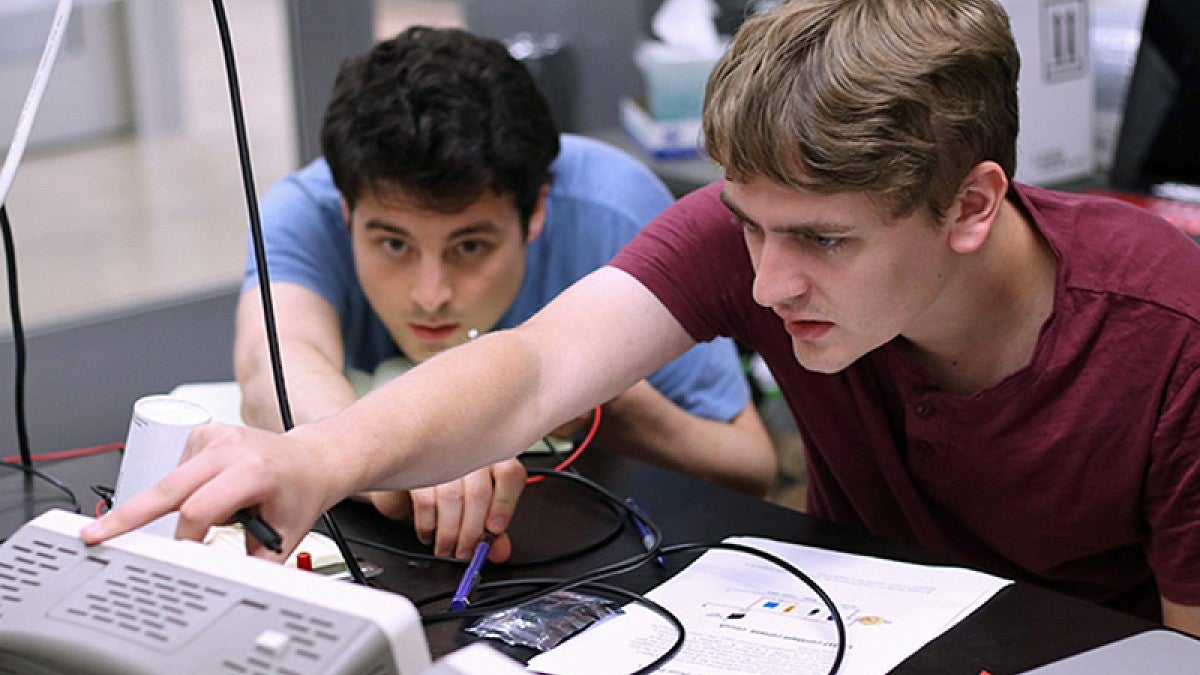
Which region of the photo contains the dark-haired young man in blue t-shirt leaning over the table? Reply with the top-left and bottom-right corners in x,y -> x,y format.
235,26 -> 775,558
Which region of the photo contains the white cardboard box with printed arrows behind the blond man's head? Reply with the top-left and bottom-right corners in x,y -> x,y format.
1000,0 -> 1096,185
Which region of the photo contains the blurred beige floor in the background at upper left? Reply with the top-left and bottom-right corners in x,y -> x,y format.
0,0 -> 461,334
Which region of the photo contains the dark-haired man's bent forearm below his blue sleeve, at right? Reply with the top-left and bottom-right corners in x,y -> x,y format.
596,380 -> 776,497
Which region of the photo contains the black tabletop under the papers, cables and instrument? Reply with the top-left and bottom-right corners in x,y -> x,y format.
0,449 -> 1156,675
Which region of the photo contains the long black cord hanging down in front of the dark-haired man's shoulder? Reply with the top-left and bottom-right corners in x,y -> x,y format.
212,0 -> 367,586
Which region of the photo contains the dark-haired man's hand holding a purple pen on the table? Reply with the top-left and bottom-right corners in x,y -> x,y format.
368,459 -> 526,562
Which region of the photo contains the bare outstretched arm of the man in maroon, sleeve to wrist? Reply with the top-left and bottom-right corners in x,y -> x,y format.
295,268 -> 694,491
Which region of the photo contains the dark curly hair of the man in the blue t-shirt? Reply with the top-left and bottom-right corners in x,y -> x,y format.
320,26 -> 559,227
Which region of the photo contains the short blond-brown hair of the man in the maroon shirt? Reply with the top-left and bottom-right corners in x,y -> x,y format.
703,0 -> 1020,216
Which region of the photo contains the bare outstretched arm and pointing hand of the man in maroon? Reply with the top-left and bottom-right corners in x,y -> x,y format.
84,268 -> 694,550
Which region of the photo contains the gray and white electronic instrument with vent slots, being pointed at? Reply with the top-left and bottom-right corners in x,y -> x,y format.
0,510 -> 430,675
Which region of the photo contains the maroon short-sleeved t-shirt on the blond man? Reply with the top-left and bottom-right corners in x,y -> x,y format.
612,177 -> 1200,617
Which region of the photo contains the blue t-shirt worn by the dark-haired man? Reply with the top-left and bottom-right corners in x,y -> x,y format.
242,135 -> 750,420
